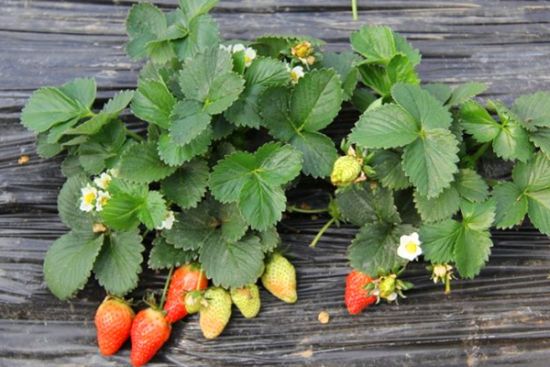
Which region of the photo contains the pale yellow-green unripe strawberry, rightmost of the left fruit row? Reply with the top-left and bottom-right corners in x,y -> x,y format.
262,253 -> 298,303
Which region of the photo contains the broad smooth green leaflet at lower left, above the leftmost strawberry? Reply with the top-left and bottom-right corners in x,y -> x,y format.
44,231 -> 103,300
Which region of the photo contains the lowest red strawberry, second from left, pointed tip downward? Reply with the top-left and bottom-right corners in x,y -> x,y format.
130,307 -> 172,367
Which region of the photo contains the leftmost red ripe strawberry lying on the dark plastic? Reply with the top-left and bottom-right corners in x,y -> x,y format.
95,297 -> 134,356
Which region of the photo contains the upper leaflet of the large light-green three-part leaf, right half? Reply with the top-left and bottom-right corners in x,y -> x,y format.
391,83 -> 452,129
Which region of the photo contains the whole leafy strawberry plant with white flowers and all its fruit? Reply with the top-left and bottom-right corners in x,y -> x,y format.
17,0 -> 550,365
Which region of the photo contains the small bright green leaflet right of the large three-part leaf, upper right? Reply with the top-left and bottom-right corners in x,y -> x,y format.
459,101 -> 500,143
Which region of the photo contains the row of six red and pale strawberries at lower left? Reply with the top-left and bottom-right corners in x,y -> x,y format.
95,253 -> 298,367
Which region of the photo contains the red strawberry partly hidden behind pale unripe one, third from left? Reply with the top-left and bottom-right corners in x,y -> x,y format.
164,264 -> 208,323
